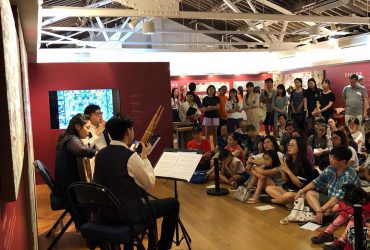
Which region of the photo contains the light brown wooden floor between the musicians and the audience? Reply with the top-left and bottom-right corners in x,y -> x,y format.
37,180 -> 322,250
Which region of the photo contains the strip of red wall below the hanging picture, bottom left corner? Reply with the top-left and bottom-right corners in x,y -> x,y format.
0,176 -> 28,250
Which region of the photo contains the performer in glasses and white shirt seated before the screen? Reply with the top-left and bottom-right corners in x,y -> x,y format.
84,104 -> 110,150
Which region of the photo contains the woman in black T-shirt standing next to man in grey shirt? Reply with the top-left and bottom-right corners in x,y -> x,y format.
317,79 -> 335,122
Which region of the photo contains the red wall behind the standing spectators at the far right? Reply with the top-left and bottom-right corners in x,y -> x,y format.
284,62 -> 370,107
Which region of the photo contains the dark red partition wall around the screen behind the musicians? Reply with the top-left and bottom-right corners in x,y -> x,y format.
29,63 -> 172,183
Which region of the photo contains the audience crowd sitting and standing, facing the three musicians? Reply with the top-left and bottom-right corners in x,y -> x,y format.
175,75 -> 370,249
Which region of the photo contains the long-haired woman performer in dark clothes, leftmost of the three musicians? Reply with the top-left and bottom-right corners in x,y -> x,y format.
55,114 -> 96,193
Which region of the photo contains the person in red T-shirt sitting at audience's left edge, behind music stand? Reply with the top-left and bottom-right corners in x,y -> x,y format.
186,125 -> 212,170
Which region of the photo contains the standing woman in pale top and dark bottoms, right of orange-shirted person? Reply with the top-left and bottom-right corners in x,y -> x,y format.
226,88 -> 243,133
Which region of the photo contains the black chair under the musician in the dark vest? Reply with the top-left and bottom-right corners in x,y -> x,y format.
68,182 -> 156,250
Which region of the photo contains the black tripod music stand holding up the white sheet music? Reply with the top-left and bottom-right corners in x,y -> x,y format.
151,148 -> 201,250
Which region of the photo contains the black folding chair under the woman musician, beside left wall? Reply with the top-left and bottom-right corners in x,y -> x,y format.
33,160 -> 73,250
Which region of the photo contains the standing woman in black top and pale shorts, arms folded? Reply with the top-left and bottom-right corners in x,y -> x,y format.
202,85 -> 220,145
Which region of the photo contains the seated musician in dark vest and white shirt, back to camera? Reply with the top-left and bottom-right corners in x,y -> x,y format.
94,113 -> 179,250
